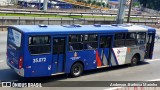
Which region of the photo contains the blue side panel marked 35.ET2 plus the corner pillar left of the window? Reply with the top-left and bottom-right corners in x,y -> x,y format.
24,36 -> 52,77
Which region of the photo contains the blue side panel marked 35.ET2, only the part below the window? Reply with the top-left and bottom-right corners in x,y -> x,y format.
25,55 -> 52,77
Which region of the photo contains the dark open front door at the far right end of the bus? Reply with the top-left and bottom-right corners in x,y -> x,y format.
145,33 -> 155,59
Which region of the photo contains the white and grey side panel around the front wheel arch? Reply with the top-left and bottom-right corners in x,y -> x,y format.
111,45 -> 145,66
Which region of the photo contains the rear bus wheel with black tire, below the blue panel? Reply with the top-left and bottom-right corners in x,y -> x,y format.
70,63 -> 83,77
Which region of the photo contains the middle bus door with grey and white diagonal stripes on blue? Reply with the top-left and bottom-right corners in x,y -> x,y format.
99,36 -> 112,66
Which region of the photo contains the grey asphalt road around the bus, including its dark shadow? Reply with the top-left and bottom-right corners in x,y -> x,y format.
0,31 -> 160,90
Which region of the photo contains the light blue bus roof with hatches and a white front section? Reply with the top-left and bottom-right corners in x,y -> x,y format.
9,24 -> 155,34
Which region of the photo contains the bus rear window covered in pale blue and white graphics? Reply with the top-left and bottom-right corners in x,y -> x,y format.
8,28 -> 22,47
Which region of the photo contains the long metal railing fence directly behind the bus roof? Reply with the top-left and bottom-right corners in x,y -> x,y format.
0,16 -> 159,30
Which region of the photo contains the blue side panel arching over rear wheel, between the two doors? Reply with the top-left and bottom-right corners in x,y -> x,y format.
65,50 -> 97,73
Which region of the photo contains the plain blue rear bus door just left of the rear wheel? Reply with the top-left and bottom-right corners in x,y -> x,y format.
52,38 -> 66,74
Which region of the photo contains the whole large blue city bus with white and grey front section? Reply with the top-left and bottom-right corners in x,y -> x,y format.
7,24 -> 156,77
